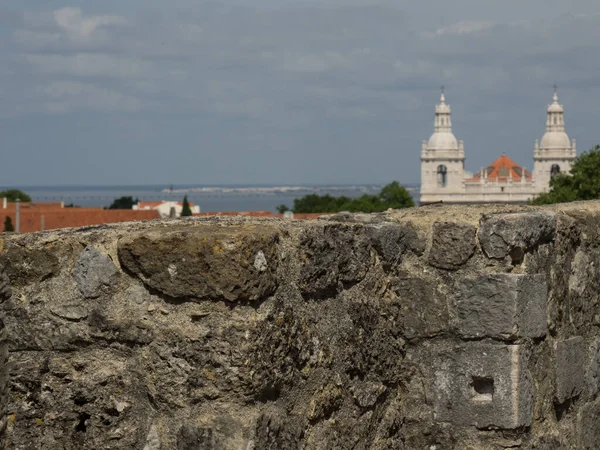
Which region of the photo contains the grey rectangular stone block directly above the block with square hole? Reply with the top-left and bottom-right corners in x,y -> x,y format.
456,274 -> 548,339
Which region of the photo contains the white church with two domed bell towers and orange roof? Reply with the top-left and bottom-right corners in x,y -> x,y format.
420,89 -> 576,204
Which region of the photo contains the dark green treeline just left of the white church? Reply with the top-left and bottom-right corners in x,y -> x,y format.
277,181 -> 415,213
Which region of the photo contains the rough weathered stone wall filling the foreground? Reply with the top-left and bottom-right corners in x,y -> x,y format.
0,203 -> 600,450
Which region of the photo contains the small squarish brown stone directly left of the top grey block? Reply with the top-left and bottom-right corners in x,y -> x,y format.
428,222 -> 477,270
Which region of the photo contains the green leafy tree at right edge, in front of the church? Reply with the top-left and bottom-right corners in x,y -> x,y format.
530,145 -> 600,205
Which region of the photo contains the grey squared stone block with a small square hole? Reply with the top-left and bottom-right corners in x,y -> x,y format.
433,343 -> 533,429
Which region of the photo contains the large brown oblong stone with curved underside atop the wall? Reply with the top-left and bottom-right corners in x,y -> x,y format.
118,226 -> 279,301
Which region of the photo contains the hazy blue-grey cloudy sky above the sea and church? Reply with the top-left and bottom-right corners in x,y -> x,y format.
0,0 -> 600,186
